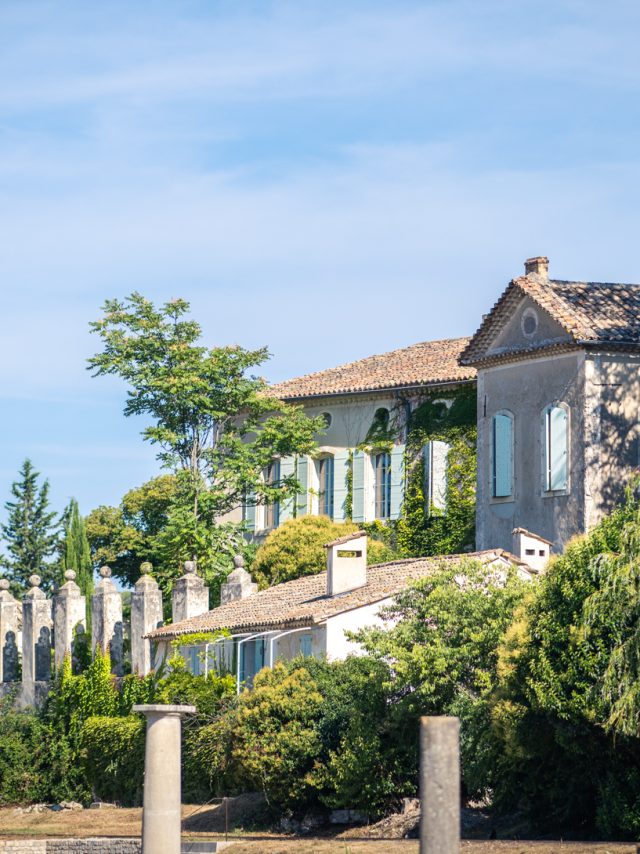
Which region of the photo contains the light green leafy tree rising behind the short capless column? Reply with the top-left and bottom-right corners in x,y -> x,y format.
355,560 -> 526,794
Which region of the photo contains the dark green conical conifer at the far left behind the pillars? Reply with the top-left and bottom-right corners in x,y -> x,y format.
0,459 -> 60,594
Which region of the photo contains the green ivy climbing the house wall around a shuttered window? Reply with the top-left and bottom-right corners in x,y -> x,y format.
395,388 -> 477,557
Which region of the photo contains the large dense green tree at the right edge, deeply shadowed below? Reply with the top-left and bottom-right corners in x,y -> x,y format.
492,495 -> 640,838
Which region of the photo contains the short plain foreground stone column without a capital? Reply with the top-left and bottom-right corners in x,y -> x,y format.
420,717 -> 460,854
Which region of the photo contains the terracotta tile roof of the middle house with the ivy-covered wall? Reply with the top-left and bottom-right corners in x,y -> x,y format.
271,338 -> 476,400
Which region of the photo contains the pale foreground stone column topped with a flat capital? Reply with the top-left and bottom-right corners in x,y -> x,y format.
133,706 -> 195,854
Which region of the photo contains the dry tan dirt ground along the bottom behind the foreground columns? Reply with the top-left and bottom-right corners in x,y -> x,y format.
0,805 -> 638,854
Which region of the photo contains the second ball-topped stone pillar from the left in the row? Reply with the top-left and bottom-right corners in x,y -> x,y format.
22,575 -> 52,698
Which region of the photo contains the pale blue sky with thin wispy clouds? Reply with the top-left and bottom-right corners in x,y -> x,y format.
0,0 -> 640,512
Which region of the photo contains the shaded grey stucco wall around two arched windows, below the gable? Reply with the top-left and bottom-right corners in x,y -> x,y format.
476,352 -> 586,551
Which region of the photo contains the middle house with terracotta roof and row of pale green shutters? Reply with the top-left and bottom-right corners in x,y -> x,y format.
244,338 -> 475,538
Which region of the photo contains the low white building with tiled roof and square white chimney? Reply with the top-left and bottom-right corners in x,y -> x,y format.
148,531 -> 534,690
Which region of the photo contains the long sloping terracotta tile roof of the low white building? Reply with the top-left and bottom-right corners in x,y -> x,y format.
146,549 -> 524,640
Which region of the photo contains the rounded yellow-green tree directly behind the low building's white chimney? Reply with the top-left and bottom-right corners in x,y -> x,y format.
251,516 -> 395,588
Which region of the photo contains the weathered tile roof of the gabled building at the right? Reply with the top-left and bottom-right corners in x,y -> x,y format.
460,273 -> 640,365
